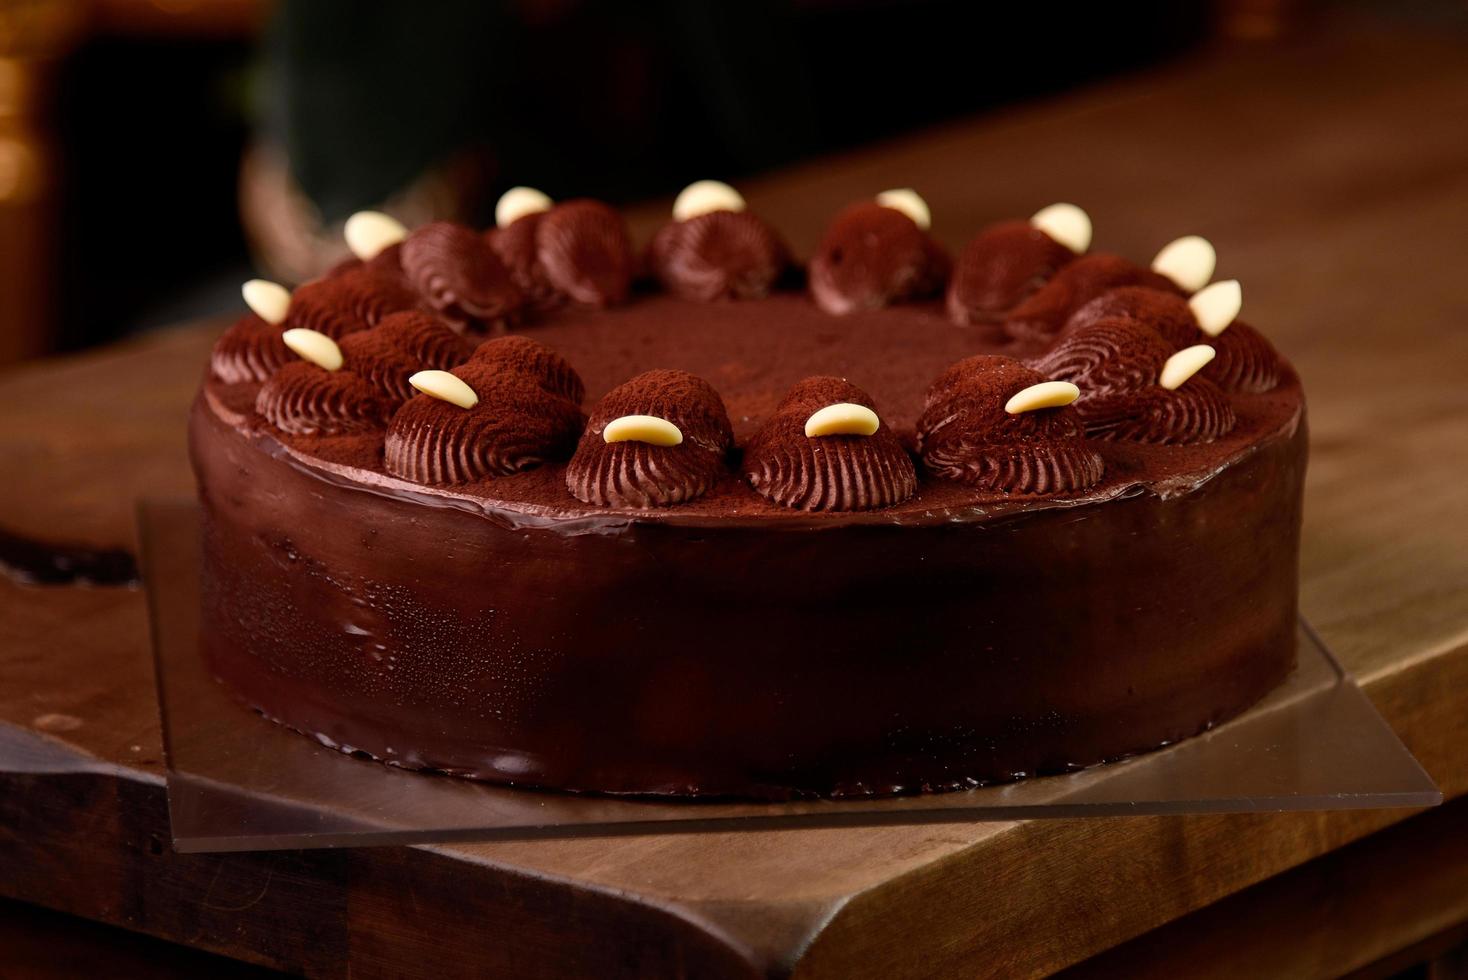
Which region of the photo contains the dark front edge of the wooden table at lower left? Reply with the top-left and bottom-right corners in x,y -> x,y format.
0,773 -> 763,980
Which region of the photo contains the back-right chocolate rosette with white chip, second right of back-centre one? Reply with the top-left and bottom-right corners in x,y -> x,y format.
947,204 -> 1091,324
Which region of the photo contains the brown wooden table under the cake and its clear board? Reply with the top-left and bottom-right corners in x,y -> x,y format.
0,19 -> 1468,977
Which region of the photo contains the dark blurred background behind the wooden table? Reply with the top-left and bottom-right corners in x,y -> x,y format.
0,0 -> 1461,364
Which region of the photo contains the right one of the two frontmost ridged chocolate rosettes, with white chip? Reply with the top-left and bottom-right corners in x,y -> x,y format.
743,377 -> 918,511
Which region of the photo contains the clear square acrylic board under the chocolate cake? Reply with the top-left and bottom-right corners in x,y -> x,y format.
139,502 -> 1442,851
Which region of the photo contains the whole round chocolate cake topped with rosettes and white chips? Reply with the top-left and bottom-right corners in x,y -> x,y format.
191,182 -> 1305,798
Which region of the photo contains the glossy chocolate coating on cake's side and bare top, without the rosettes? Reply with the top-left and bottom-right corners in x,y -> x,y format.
191,281 -> 1305,797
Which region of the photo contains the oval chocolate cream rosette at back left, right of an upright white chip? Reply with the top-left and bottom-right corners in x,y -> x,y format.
402,222 -> 523,333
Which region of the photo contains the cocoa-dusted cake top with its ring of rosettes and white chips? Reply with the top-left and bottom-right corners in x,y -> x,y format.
204,185 -> 1304,530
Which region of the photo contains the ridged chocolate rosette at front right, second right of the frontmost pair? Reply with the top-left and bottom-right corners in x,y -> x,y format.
1031,318 -> 1235,443
